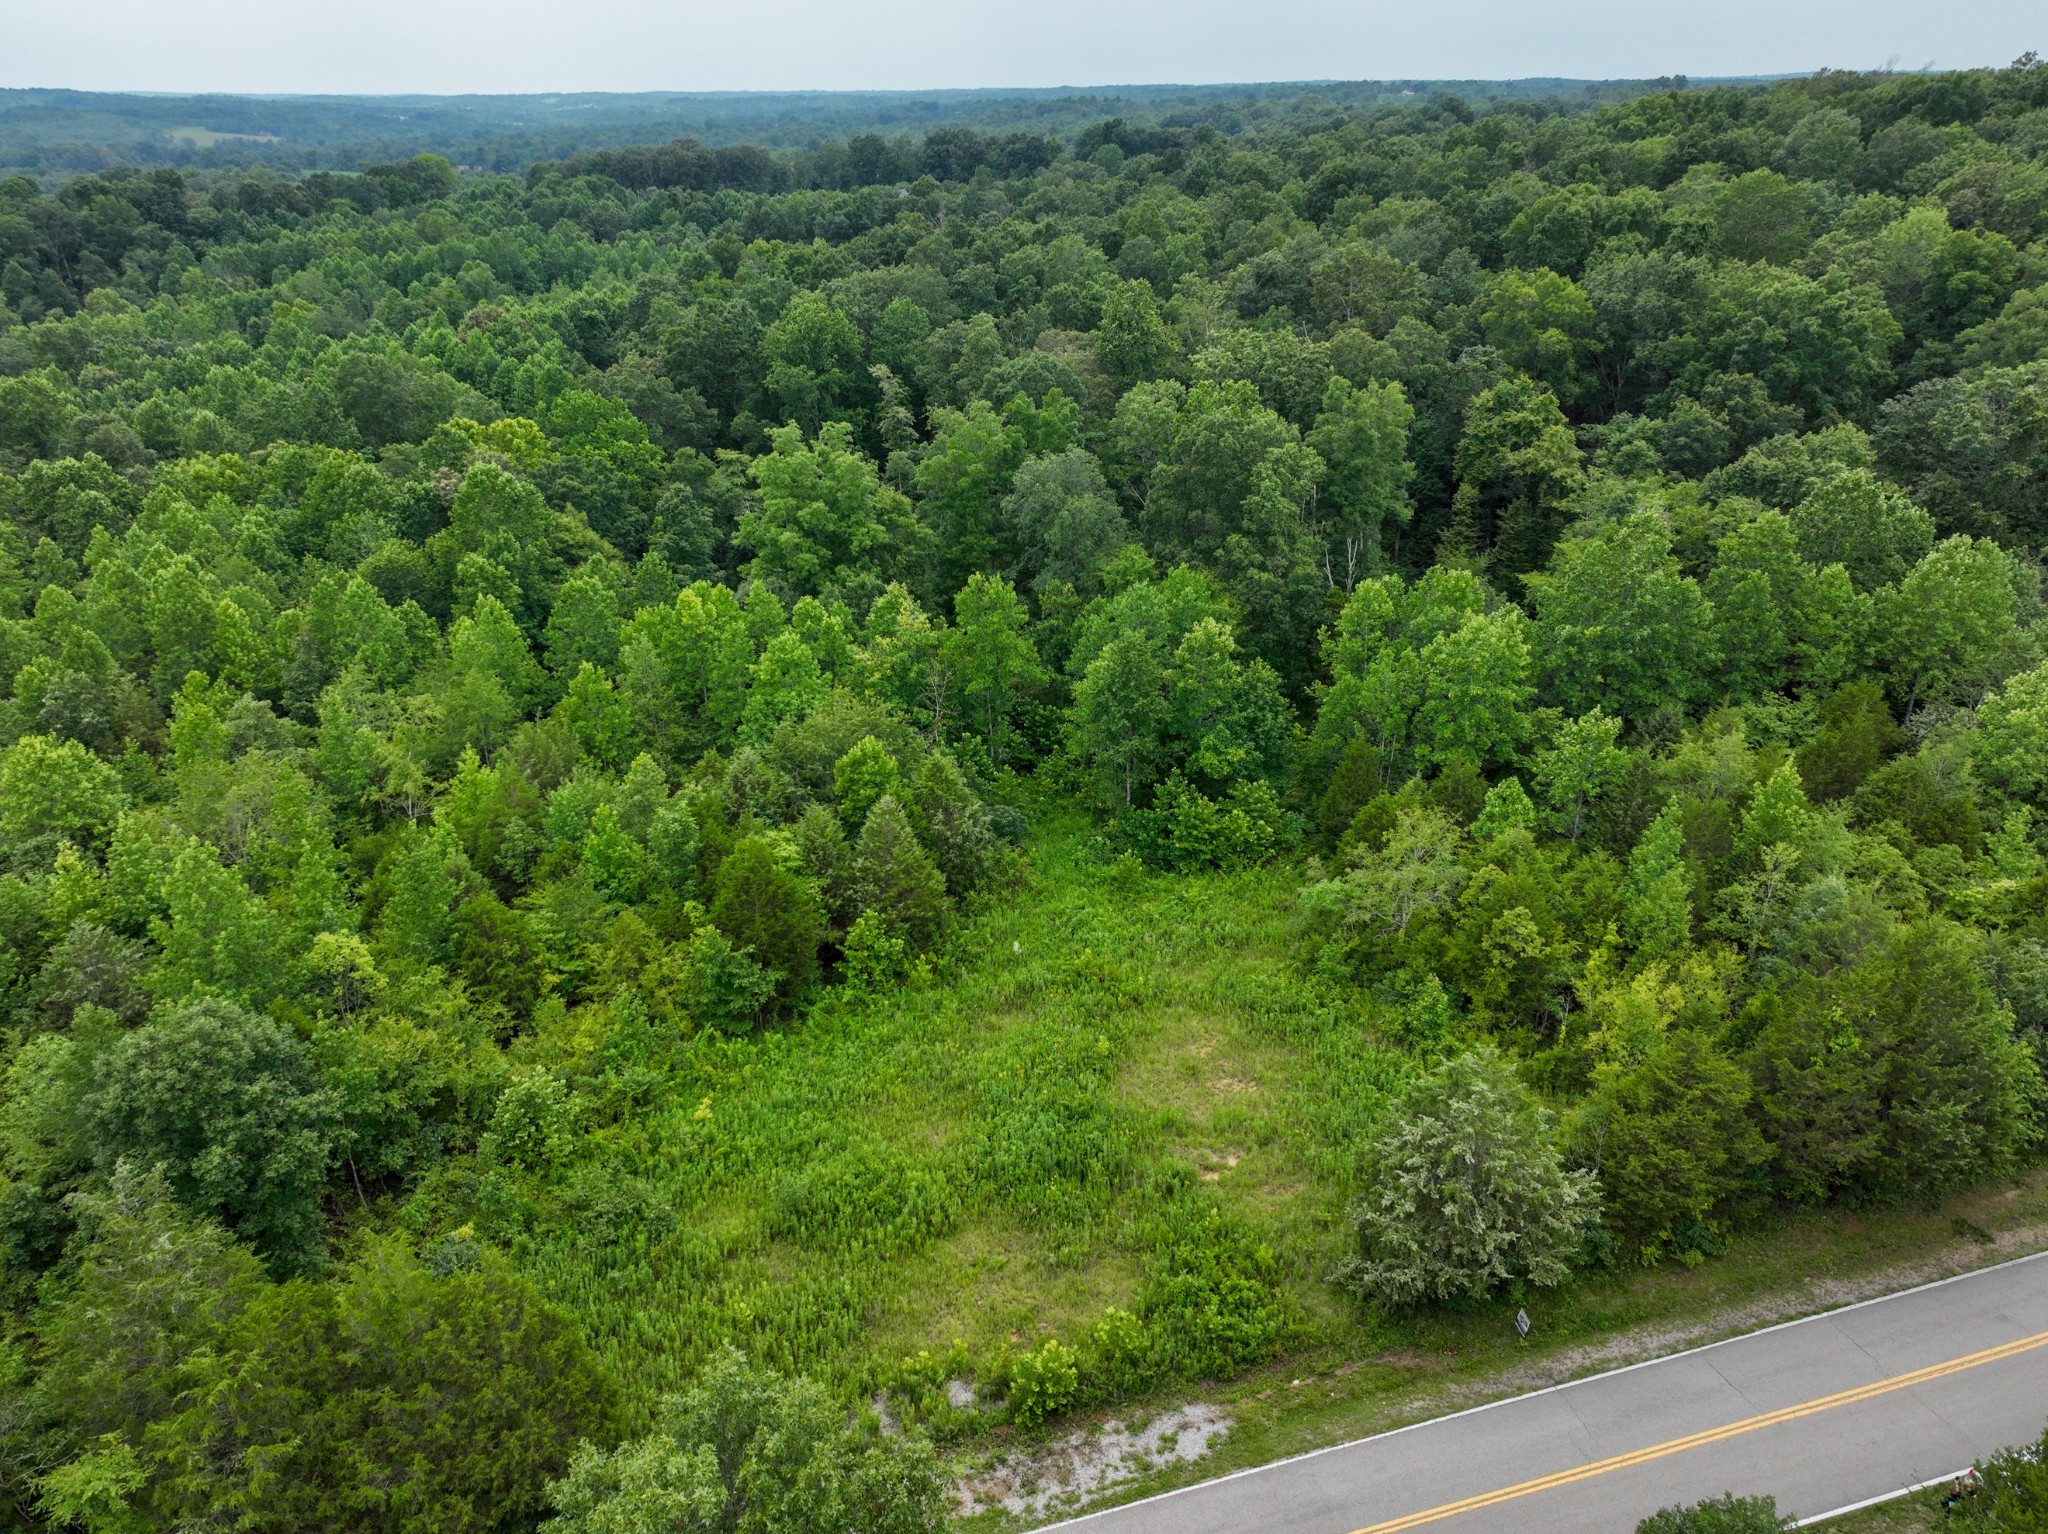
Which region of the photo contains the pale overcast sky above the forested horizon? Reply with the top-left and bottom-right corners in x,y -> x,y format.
0,0 -> 2048,94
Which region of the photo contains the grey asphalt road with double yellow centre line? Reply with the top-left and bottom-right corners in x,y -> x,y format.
1055,1253 -> 2048,1534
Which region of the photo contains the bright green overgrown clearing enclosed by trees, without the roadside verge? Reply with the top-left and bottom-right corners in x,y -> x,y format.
481,823 -> 1401,1405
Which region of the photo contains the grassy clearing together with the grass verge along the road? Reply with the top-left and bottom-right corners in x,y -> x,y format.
469,817 -> 2048,1524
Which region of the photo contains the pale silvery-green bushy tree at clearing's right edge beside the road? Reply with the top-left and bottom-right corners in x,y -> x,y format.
1339,1051 -> 1599,1307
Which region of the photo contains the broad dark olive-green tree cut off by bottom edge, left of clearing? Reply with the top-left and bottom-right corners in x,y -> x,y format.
154,1239 -> 614,1534
